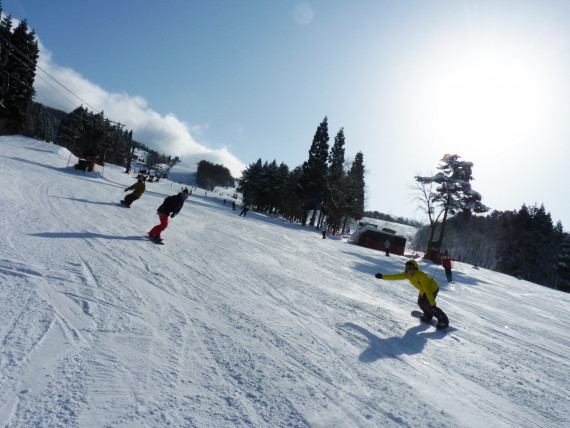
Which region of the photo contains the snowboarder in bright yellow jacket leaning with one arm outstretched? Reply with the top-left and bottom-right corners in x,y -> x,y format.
375,260 -> 449,329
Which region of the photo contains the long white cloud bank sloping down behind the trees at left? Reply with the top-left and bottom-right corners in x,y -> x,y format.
34,40 -> 245,177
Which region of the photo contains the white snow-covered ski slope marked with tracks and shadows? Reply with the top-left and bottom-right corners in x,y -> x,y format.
0,137 -> 570,428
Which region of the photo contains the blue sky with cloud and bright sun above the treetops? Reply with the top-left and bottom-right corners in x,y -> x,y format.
3,0 -> 570,229
